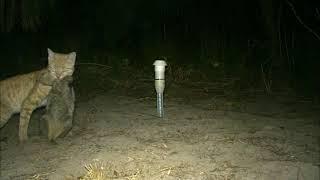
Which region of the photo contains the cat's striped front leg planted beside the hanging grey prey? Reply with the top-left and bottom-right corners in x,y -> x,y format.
19,84 -> 51,142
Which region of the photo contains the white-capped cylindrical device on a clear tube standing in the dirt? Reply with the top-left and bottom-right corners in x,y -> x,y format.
153,60 -> 167,117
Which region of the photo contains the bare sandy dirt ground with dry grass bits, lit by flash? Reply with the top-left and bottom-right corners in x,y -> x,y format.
1,82 -> 320,180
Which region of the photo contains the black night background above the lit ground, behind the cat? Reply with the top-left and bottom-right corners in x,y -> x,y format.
0,0 -> 320,96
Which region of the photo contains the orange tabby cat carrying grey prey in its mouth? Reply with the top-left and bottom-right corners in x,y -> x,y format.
0,49 -> 76,142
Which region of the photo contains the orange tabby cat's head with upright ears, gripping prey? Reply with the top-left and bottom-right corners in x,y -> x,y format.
48,48 -> 76,80
